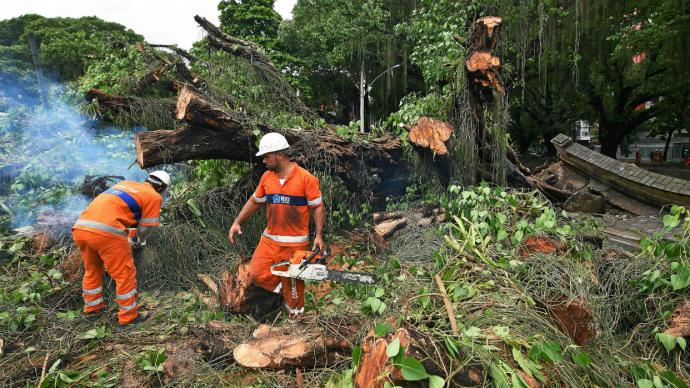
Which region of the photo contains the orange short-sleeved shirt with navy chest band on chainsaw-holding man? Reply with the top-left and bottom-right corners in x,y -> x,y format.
252,164 -> 322,245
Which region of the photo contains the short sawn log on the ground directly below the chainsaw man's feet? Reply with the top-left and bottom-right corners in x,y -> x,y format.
232,322 -> 354,369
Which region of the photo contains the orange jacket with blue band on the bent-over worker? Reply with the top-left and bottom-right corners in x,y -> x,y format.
72,181 -> 163,239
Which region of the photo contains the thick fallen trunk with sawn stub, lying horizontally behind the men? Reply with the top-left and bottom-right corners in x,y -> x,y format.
135,88 -> 410,197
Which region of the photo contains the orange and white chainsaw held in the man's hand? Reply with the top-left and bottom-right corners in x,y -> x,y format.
271,248 -> 376,284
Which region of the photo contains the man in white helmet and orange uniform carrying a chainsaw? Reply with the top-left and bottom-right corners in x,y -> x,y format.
228,133 -> 326,318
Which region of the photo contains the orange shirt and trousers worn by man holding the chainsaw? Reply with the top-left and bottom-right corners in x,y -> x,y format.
249,165 -> 322,316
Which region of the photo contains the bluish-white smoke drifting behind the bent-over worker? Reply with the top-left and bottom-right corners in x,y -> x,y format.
0,77 -> 146,228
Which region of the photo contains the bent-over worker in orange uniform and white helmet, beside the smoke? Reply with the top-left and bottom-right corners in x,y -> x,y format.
72,171 -> 170,327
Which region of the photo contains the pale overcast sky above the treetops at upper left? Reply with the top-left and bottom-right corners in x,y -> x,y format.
0,0 -> 296,49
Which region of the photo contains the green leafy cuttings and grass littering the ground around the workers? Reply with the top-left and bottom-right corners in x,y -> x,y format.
0,186 -> 690,386
